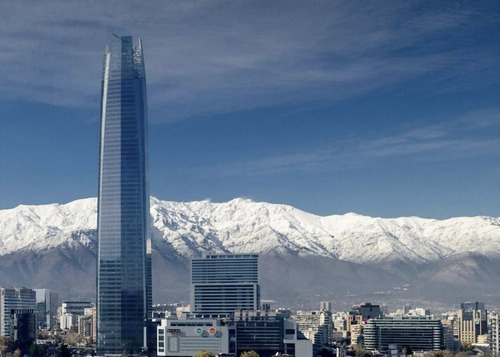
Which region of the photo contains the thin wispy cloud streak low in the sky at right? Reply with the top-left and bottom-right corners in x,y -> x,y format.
197,108 -> 500,176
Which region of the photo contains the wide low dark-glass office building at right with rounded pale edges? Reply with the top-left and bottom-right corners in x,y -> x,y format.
364,316 -> 445,353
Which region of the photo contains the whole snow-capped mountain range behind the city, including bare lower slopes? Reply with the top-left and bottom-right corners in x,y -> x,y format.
0,197 -> 500,308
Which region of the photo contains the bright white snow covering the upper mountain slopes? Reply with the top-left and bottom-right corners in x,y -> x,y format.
0,198 -> 500,263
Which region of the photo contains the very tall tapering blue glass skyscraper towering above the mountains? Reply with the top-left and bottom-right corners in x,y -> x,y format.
97,35 -> 152,355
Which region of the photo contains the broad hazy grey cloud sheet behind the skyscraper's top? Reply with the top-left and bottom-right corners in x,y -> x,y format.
0,0 -> 496,120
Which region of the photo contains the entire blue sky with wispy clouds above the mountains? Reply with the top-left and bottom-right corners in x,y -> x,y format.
0,0 -> 500,218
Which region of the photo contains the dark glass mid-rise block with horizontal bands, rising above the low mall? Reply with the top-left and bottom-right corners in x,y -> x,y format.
191,254 -> 260,315
